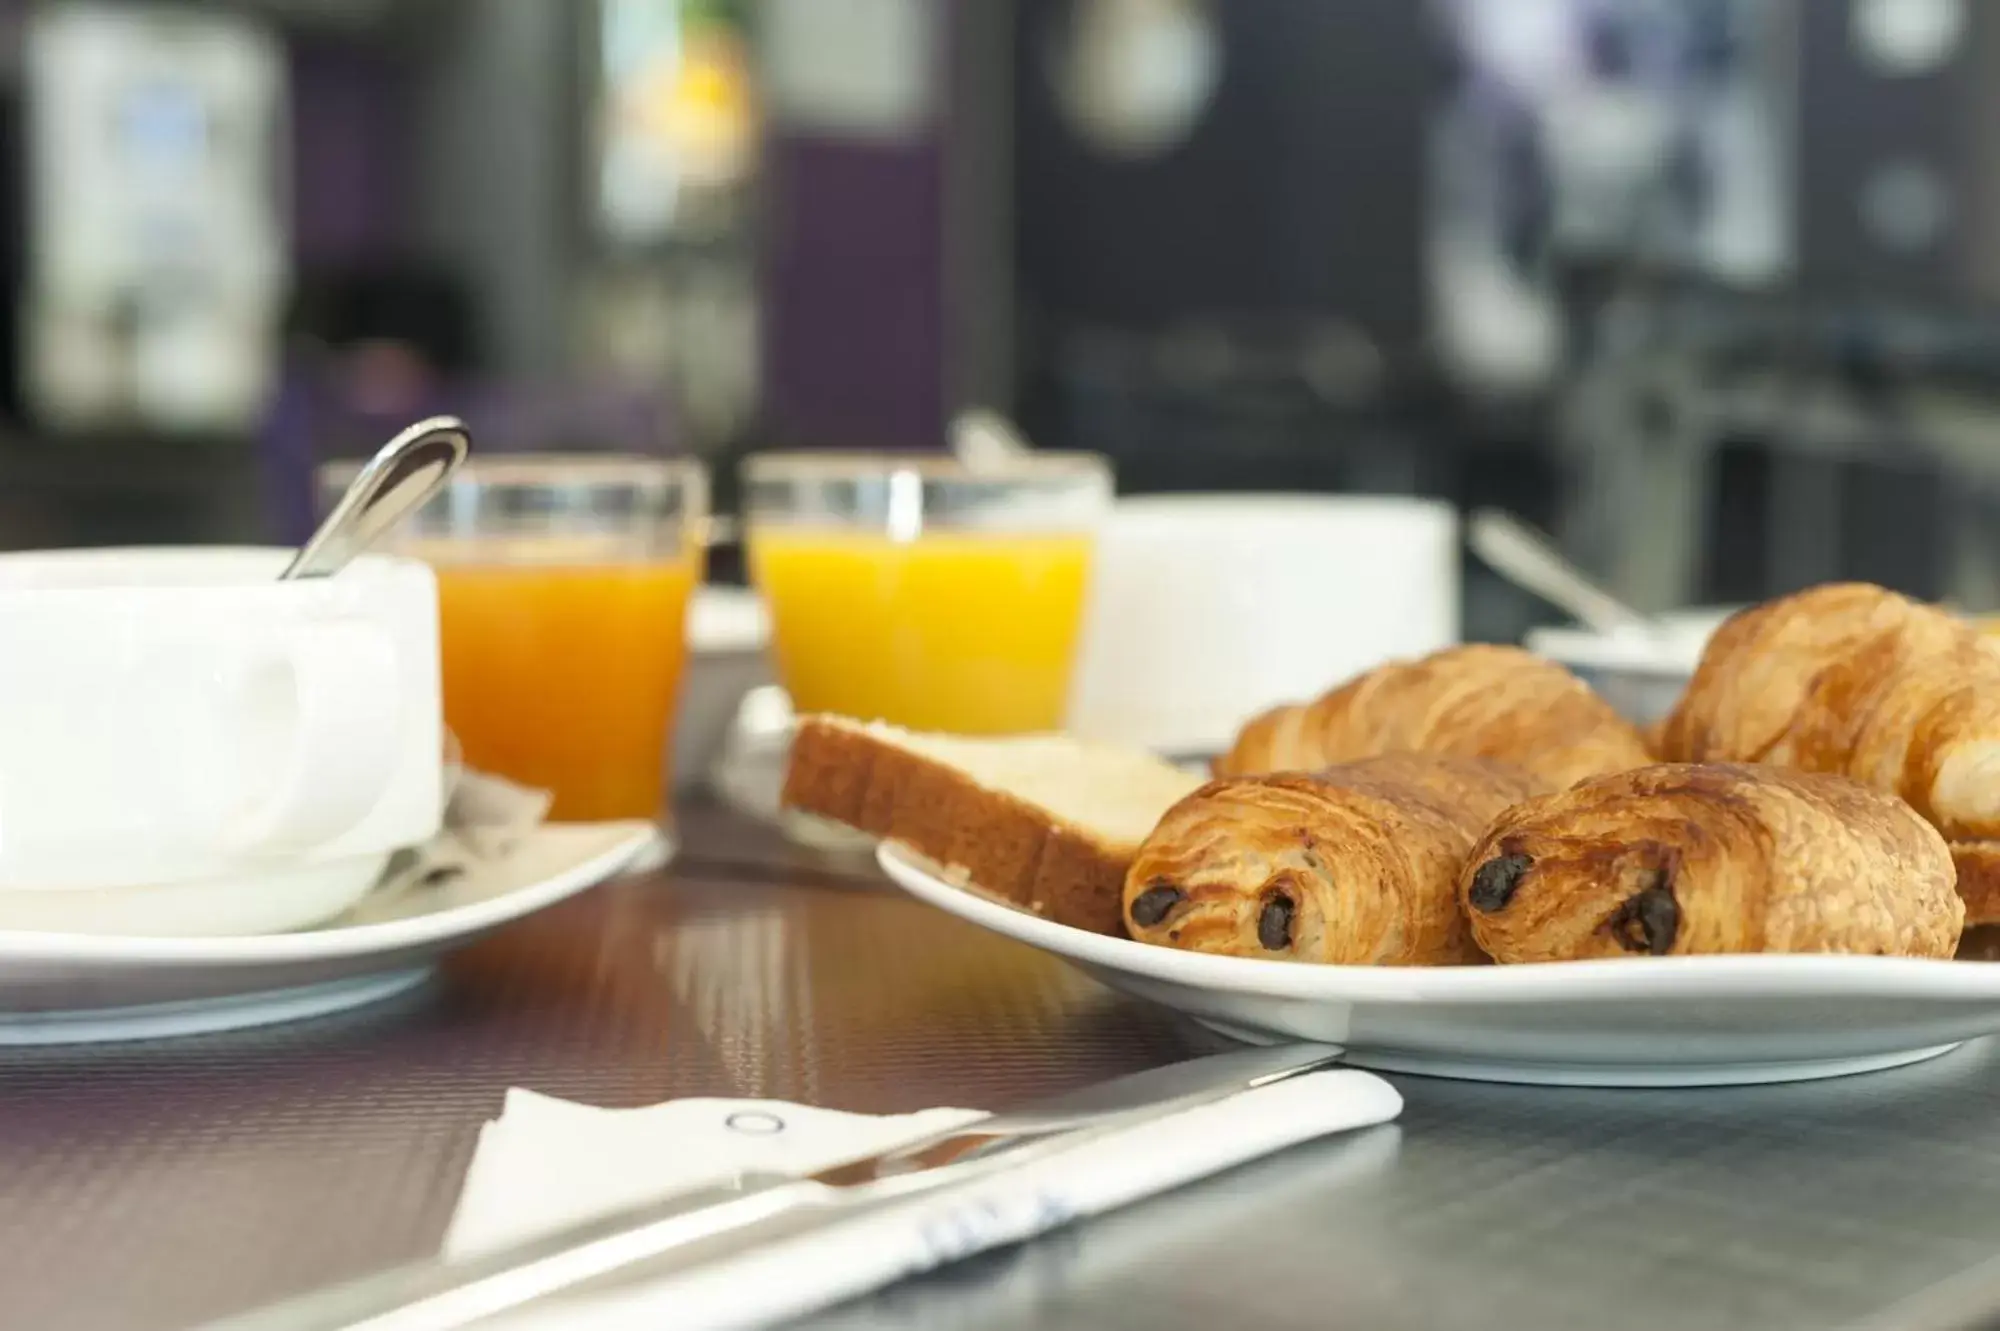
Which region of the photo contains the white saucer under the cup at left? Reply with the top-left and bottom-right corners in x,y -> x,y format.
0,823 -> 662,1045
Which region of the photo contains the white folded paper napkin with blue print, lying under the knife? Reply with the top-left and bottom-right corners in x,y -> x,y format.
444,1069 -> 1402,1331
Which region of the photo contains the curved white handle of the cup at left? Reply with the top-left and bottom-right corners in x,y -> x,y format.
226,620 -> 402,851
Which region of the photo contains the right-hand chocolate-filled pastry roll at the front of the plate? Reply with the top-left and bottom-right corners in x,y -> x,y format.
1460,763 -> 1964,961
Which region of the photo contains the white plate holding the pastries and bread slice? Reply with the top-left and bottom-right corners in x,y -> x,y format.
876,845 -> 2000,1085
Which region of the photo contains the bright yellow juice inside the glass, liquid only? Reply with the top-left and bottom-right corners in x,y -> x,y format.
750,524 -> 1092,735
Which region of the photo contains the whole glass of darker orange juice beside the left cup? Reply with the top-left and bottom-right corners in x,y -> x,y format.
322,454 -> 708,821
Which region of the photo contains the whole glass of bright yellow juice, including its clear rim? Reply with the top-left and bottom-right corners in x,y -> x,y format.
744,454 -> 1112,735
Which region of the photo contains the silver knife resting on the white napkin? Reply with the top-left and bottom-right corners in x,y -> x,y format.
210,1043 -> 1340,1331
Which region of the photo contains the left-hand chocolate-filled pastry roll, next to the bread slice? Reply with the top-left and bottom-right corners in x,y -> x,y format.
1124,753 -> 1548,965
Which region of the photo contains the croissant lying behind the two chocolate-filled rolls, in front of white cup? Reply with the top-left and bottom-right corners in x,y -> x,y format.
1214,646 -> 1654,785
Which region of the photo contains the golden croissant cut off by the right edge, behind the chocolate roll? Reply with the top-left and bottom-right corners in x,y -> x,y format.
1660,584 -> 2000,841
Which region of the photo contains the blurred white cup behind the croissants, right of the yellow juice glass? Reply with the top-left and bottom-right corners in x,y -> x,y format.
1070,494 -> 1458,755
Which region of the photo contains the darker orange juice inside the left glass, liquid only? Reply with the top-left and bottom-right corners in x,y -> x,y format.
436,556 -> 700,819
